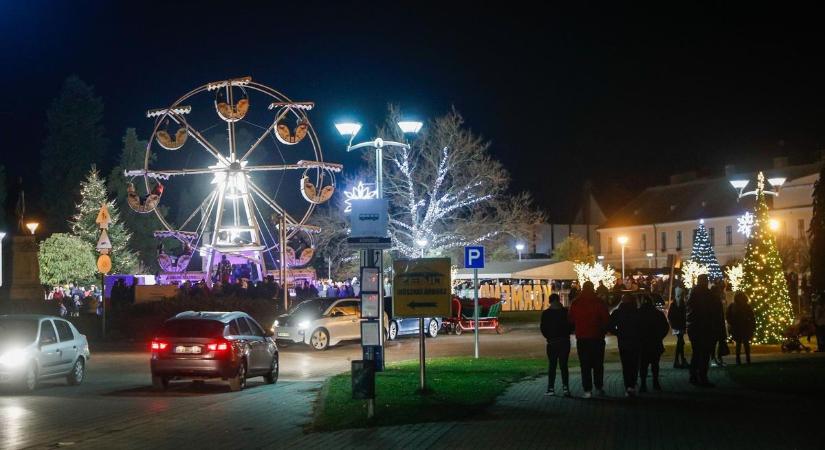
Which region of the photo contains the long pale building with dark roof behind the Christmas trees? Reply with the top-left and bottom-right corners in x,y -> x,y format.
598,158 -> 823,270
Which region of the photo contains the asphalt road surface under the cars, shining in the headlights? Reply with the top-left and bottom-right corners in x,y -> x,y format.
0,330 -> 560,449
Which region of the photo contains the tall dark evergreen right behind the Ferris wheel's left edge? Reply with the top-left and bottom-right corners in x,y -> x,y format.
107,128 -> 166,271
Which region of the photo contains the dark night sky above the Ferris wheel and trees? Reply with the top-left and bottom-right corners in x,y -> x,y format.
0,0 -> 825,221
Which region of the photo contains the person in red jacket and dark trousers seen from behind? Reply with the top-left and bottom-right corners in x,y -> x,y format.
567,281 -> 610,398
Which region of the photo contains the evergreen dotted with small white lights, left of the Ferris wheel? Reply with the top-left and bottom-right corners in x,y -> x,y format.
70,166 -> 138,273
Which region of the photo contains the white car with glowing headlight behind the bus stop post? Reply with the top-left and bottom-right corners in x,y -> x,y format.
272,297 -> 386,350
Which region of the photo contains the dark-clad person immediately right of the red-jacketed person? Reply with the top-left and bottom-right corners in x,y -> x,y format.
608,294 -> 642,397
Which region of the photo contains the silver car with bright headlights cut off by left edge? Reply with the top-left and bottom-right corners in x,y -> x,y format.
0,315 -> 91,391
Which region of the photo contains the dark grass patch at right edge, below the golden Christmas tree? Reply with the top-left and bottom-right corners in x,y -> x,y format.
728,355 -> 825,396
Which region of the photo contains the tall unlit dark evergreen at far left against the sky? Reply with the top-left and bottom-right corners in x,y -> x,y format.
40,76 -> 106,230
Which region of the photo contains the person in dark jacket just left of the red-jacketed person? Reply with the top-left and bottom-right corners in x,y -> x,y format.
541,294 -> 573,397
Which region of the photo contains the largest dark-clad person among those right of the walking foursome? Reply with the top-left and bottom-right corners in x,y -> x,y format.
686,274 -> 722,387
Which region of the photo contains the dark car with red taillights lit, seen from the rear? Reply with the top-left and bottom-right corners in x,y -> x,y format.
151,311 -> 279,391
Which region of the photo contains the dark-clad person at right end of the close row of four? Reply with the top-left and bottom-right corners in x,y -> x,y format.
639,297 -> 670,392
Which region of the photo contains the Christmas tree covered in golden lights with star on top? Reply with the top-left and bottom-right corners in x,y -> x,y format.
741,172 -> 793,344
